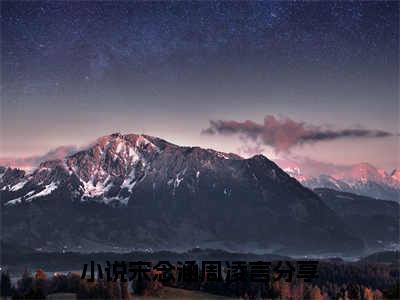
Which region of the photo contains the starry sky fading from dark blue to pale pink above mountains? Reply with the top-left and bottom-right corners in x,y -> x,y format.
0,1 -> 400,169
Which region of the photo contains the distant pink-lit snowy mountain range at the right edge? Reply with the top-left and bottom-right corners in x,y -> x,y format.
284,163 -> 400,202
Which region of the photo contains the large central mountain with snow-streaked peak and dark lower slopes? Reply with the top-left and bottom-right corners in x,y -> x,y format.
0,134 -> 363,253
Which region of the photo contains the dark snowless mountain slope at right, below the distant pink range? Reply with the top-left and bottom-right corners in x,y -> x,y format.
314,188 -> 400,251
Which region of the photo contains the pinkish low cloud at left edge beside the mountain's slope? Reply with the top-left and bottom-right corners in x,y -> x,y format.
0,146 -> 78,170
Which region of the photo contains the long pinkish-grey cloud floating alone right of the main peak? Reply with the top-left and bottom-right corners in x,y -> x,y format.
202,115 -> 395,153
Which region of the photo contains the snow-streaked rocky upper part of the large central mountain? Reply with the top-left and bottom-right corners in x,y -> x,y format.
0,133 -> 242,204
